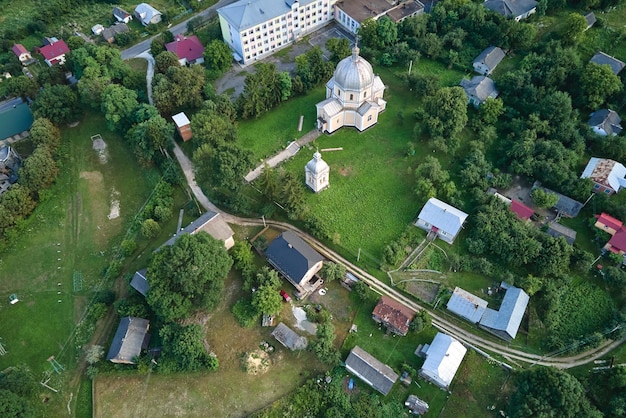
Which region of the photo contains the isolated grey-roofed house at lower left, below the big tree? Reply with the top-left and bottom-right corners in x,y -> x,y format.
107,316 -> 150,364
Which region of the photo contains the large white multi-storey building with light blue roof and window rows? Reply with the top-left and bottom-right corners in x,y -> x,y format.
217,0 -> 336,64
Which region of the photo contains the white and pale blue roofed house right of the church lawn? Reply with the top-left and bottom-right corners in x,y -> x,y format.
415,197 -> 467,244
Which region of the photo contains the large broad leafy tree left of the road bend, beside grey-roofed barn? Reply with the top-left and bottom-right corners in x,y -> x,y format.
148,232 -> 233,321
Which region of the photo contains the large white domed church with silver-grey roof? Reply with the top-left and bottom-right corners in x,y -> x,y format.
316,46 -> 387,133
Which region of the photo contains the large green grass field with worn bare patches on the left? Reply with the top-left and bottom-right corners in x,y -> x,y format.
0,115 -> 152,376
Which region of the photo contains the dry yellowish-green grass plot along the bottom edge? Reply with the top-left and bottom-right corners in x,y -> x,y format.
94,273 -> 325,417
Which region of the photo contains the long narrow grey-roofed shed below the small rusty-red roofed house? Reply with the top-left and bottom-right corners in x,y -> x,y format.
346,345 -> 399,396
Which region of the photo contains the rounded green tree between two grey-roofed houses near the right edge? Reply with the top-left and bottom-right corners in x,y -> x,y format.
580,62 -> 622,109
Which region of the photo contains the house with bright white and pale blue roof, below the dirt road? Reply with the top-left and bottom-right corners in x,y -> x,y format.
418,332 -> 467,390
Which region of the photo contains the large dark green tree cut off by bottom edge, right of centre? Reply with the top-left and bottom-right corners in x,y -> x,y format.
509,366 -> 602,418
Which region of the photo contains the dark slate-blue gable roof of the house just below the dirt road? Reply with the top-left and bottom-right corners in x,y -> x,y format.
265,231 -> 324,284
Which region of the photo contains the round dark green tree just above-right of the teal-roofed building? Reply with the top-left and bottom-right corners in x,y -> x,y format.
33,84 -> 79,125
